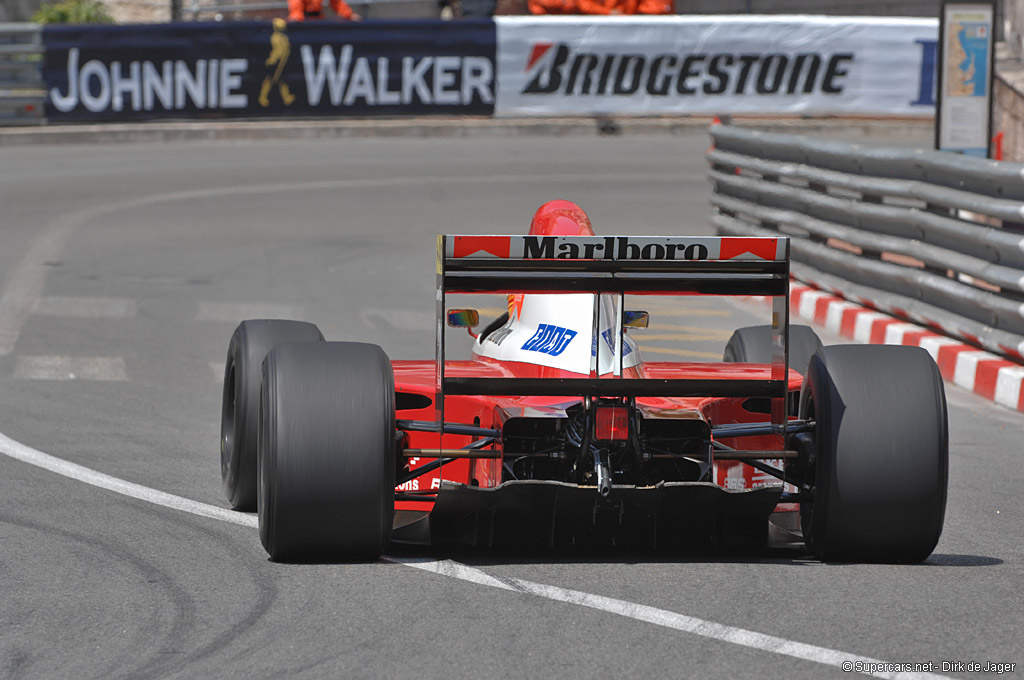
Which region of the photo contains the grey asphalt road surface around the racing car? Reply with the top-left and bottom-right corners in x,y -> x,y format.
0,129 -> 1024,679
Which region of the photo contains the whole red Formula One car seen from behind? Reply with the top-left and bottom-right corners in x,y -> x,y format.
221,201 -> 948,561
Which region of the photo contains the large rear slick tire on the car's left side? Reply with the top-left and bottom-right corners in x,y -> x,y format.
258,342 -> 395,561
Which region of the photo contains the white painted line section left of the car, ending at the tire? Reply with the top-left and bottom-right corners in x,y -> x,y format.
0,433 -> 257,528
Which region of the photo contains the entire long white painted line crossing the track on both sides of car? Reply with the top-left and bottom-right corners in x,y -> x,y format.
0,433 -> 949,680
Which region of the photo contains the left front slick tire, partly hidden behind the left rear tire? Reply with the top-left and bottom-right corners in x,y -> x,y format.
220,320 -> 324,511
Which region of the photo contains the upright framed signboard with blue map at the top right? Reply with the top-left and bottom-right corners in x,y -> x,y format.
935,0 -> 995,158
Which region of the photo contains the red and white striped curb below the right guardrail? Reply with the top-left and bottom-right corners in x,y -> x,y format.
790,283 -> 1024,412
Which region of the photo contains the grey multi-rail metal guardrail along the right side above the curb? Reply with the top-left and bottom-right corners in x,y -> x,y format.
708,125 -> 1024,360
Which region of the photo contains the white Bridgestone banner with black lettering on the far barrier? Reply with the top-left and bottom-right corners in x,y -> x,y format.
495,15 -> 938,116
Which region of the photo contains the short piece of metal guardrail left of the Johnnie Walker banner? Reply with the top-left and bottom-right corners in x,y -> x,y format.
0,24 -> 46,125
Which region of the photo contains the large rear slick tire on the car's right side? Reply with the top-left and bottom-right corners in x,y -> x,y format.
798,345 -> 949,562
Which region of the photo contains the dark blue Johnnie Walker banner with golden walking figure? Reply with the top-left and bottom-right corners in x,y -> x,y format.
43,19 -> 495,122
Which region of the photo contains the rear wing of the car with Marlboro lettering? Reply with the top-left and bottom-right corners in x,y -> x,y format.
436,235 -> 790,425
